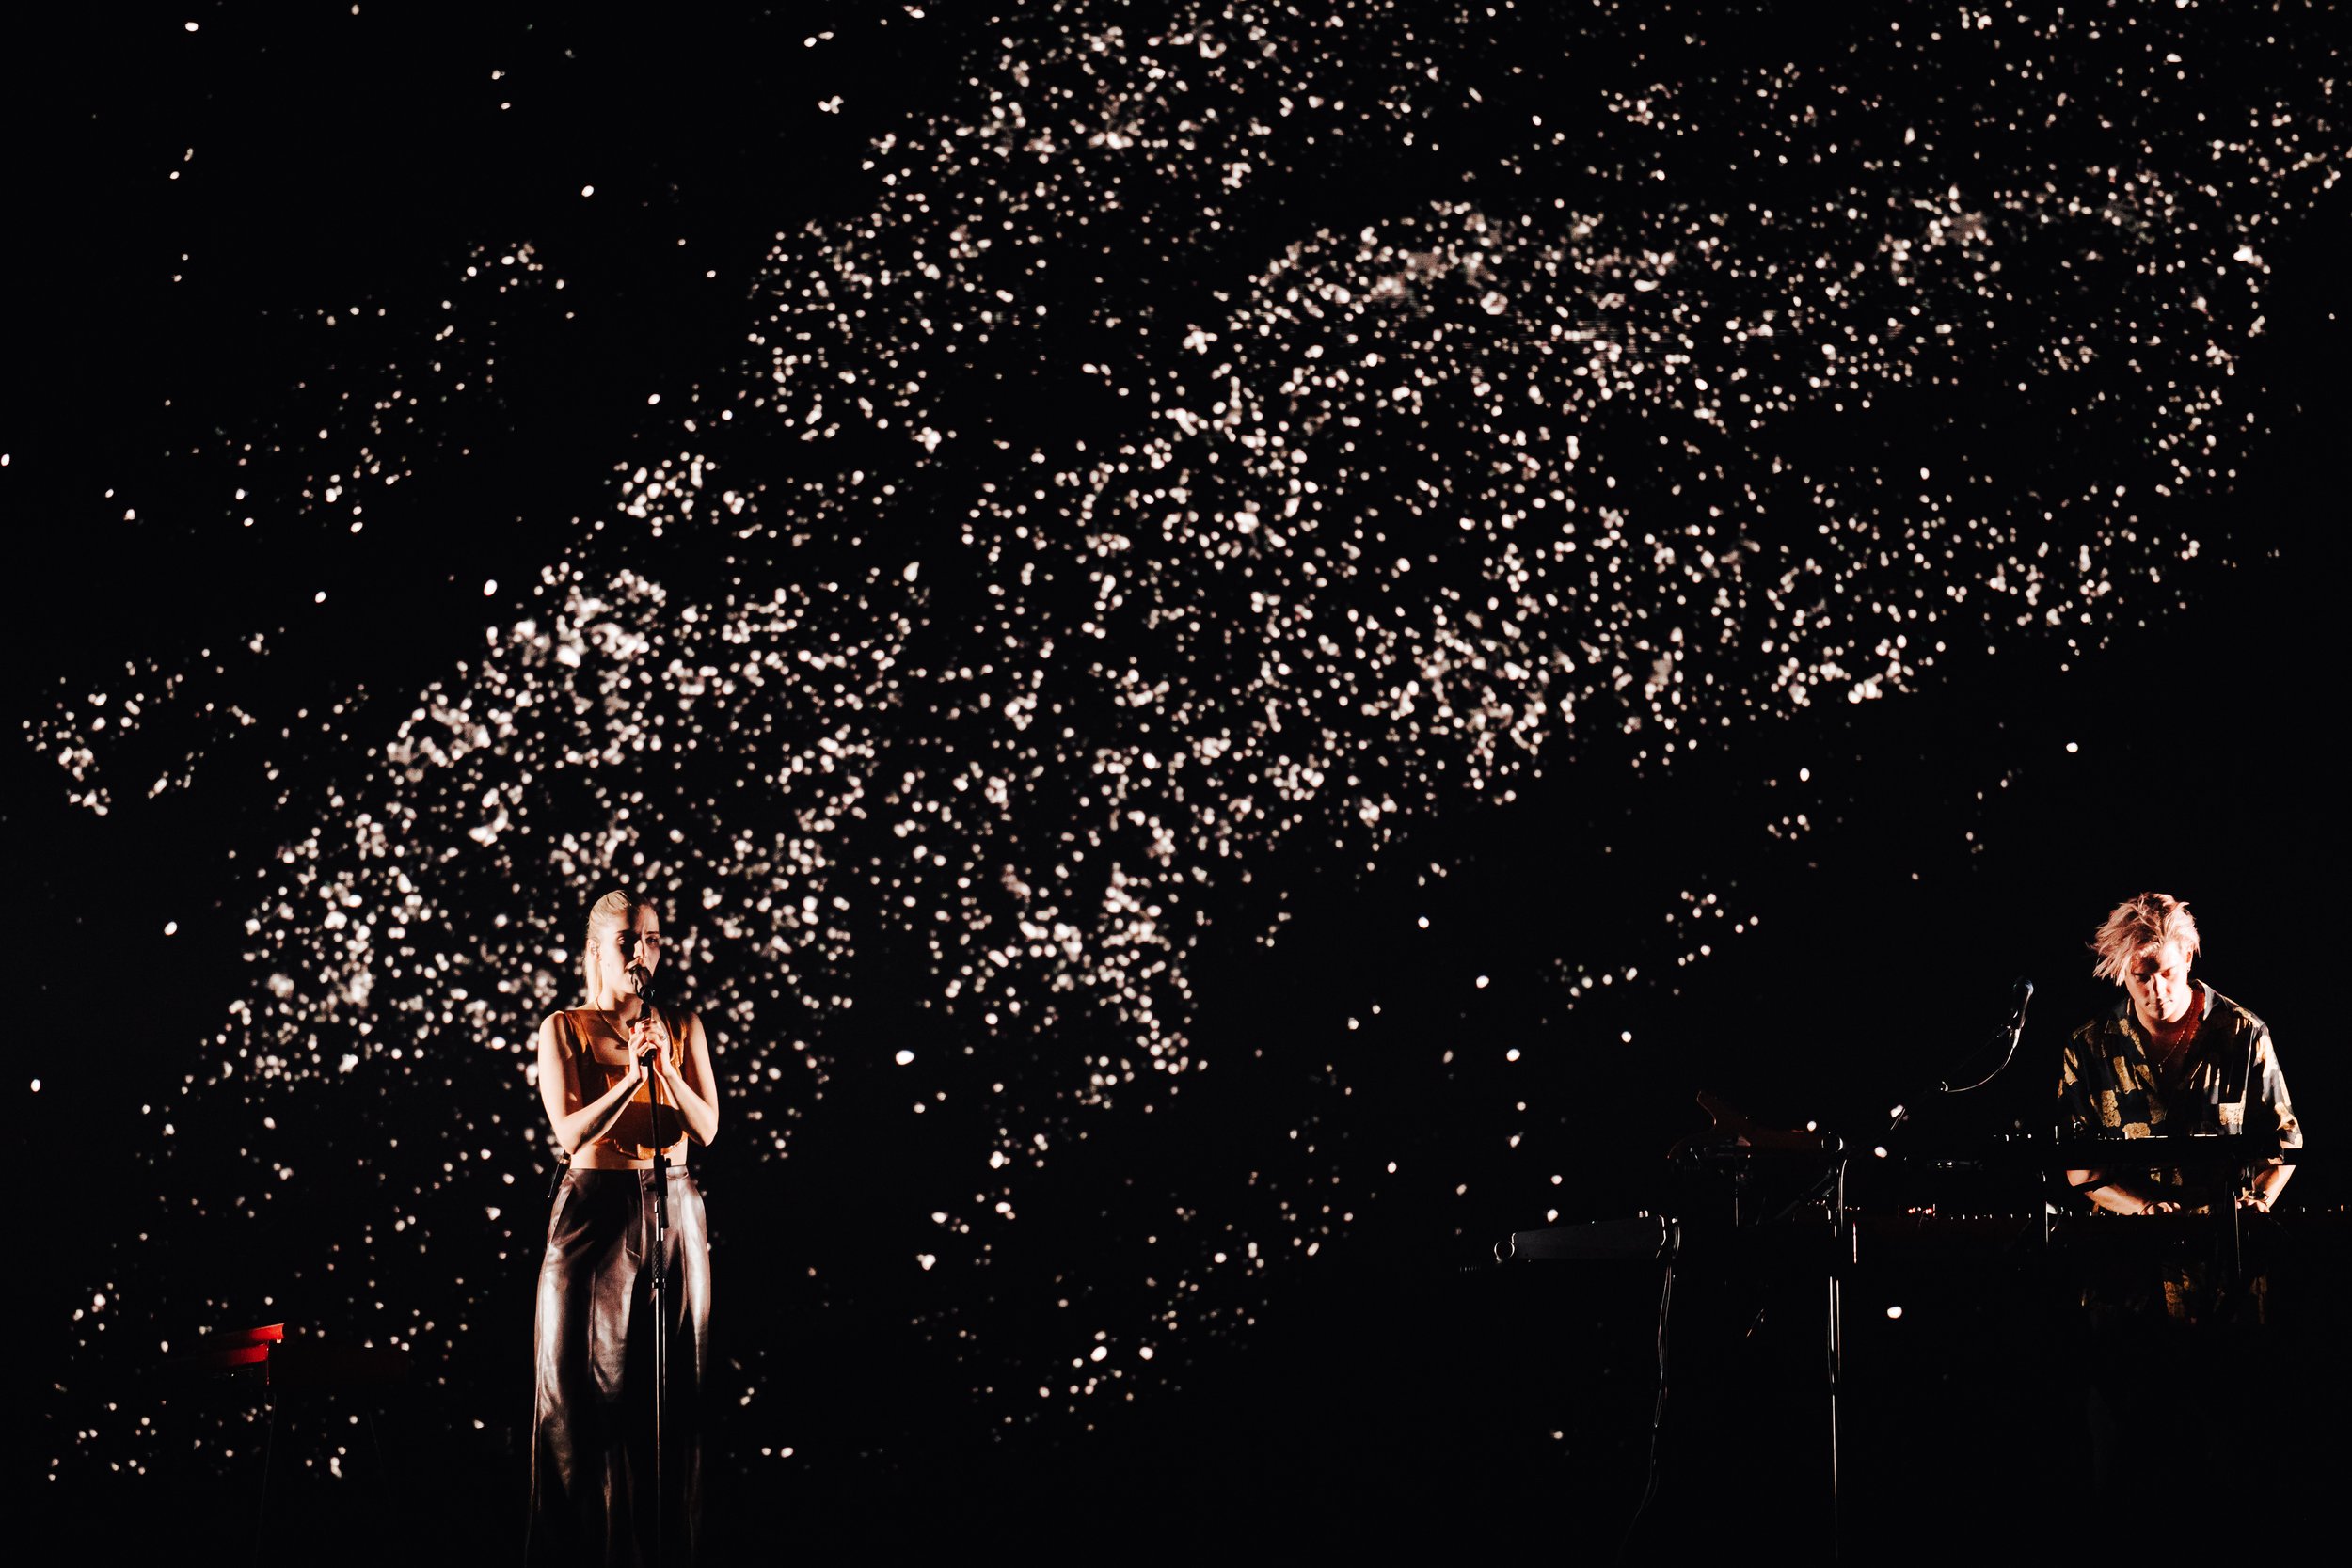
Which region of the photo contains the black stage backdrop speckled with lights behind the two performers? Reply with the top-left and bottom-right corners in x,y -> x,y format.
0,5 -> 2352,1561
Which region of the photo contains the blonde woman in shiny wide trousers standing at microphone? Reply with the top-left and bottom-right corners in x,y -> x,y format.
527,891 -> 720,1568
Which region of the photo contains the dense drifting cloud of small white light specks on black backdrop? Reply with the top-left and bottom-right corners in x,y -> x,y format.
28,2 -> 2341,1495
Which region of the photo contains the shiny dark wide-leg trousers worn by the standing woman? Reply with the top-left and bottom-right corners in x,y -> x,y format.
525,1166 -> 710,1568
